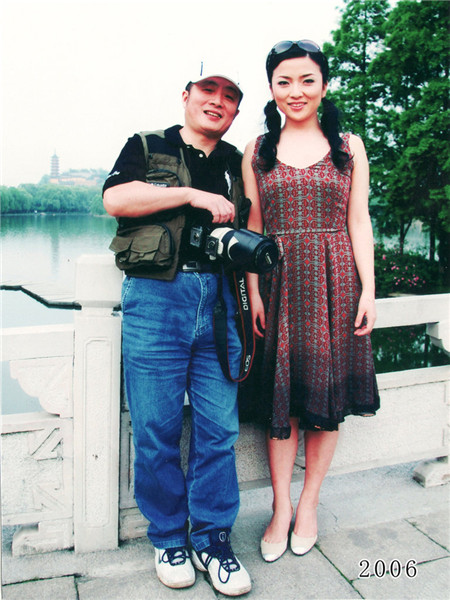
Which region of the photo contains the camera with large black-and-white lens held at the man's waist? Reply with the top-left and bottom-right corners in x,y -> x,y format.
190,227 -> 278,273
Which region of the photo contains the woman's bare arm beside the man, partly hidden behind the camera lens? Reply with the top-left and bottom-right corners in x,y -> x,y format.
242,140 -> 266,337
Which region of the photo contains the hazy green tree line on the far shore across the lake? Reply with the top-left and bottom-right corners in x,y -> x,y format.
0,183 -> 105,215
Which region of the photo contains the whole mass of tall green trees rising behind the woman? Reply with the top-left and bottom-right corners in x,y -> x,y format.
324,0 -> 450,286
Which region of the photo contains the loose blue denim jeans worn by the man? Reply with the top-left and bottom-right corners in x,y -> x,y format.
122,272 -> 241,550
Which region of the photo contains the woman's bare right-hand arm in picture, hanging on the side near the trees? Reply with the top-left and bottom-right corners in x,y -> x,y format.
347,135 -> 376,336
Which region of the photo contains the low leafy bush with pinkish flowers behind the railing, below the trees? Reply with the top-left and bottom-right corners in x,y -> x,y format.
375,244 -> 444,298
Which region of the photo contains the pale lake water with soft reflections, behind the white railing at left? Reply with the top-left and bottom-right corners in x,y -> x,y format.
1,215 -> 116,414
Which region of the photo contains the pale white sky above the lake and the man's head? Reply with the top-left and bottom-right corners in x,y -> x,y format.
0,0 -> 344,186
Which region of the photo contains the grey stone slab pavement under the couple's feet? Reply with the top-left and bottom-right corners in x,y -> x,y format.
2,464 -> 450,600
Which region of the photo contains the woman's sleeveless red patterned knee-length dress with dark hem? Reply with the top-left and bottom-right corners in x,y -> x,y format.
252,134 -> 380,439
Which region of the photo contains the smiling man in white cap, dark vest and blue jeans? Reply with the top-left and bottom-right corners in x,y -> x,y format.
103,73 -> 251,596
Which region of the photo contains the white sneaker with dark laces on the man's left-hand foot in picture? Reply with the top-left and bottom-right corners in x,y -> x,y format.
155,547 -> 195,588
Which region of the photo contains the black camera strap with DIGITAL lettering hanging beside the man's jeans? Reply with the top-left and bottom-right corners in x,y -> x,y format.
213,271 -> 255,382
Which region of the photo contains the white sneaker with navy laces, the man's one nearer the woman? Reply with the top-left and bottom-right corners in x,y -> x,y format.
192,531 -> 252,596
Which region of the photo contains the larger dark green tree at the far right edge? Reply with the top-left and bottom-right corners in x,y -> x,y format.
369,0 -> 450,282
